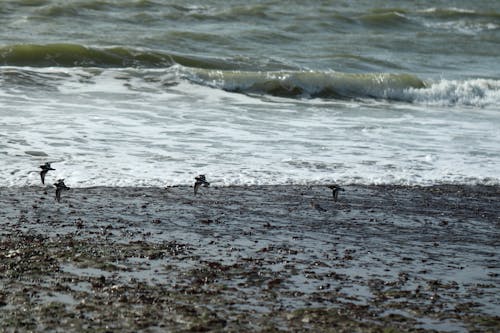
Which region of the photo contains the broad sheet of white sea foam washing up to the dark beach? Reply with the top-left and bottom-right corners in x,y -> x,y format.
0,68 -> 500,187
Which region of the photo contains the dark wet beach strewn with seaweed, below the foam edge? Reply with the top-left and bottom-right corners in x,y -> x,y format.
0,184 -> 500,332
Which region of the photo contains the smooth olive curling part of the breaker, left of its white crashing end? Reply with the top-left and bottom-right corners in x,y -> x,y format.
188,69 -> 425,99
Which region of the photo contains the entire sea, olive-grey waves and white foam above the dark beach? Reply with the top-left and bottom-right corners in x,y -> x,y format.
0,0 -> 500,187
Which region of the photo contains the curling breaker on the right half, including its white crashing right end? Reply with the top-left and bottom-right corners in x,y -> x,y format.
191,70 -> 500,107
